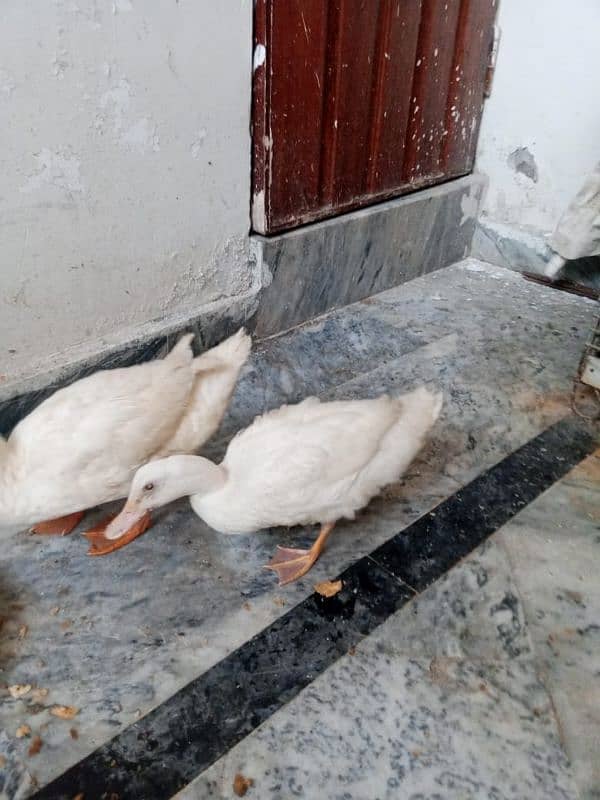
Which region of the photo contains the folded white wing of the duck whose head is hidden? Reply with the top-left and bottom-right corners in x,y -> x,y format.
9,343 -> 194,490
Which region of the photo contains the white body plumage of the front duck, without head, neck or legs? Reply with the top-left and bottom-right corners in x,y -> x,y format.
195,388 -> 442,533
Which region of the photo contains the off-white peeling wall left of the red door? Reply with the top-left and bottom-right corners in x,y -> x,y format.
0,0 -> 252,373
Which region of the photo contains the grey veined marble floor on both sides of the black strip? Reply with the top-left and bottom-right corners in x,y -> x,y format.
0,260 -> 600,800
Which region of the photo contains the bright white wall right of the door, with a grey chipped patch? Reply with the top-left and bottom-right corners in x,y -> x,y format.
477,0 -> 600,232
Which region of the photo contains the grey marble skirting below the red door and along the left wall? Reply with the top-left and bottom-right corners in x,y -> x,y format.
0,175 -> 485,436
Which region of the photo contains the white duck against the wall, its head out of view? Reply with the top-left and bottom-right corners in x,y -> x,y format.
0,330 -> 251,534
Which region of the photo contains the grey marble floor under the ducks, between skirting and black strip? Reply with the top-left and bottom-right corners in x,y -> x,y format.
0,262 -> 595,783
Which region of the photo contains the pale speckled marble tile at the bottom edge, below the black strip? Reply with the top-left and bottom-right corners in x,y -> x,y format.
182,618 -> 577,800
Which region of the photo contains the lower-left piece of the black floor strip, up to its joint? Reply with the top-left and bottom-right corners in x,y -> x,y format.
35,558 -> 413,800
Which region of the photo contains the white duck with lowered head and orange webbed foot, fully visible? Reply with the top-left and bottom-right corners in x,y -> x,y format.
98,388 -> 442,584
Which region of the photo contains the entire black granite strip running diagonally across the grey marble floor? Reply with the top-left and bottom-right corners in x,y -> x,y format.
35,418 -> 595,800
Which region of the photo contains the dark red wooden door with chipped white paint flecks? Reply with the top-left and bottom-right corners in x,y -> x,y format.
252,0 -> 496,233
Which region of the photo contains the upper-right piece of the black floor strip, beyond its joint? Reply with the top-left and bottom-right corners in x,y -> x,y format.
371,417 -> 595,592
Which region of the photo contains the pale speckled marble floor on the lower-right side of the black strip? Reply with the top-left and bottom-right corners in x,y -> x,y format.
178,452 -> 600,800
